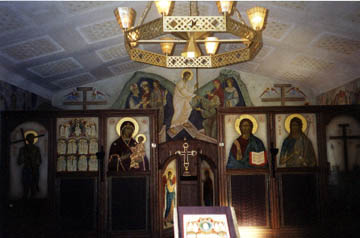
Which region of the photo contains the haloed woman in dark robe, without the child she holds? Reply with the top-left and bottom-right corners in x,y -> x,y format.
109,118 -> 149,171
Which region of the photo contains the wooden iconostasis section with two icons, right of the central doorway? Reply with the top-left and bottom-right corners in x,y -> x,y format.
219,108 -> 322,231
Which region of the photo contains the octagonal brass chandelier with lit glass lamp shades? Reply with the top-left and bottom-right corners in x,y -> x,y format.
114,0 -> 267,68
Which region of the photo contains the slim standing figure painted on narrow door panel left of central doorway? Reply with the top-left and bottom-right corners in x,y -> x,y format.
162,169 -> 176,228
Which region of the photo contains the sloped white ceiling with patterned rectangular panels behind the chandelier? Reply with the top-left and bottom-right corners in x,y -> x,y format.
0,1 -> 360,98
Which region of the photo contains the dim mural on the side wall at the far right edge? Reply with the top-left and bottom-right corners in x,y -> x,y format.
317,78 -> 360,105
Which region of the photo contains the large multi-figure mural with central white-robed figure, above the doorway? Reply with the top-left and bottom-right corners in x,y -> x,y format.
112,69 -> 252,143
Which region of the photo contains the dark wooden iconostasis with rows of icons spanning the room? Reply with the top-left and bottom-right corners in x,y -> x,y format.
1,106 -> 360,237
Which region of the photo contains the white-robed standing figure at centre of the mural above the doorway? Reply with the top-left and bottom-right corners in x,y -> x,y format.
170,70 -> 197,133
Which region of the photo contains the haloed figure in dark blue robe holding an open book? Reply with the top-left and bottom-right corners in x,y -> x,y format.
226,115 -> 267,169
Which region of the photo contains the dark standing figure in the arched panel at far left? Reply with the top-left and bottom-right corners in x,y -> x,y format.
17,133 -> 41,199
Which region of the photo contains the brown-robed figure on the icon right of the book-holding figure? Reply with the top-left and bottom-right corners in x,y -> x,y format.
280,117 -> 316,167
